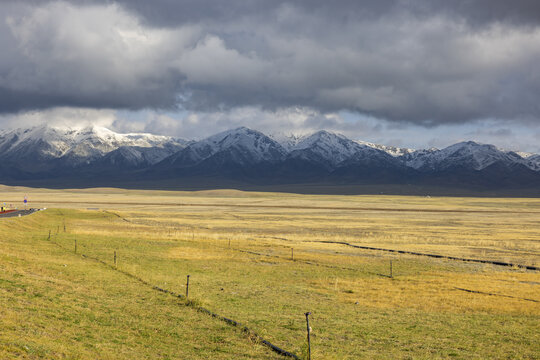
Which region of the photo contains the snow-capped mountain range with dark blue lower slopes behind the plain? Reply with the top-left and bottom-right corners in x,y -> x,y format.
0,125 -> 540,194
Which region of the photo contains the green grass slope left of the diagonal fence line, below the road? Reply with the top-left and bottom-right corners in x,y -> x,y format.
0,212 -> 276,359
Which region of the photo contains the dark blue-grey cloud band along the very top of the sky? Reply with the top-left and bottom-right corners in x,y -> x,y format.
51,0 -> 540,26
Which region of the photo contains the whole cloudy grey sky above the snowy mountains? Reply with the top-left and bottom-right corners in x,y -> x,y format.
0,0 -> 540,152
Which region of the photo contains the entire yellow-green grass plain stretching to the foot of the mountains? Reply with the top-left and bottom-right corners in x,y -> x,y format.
0,187 -> 540,359
